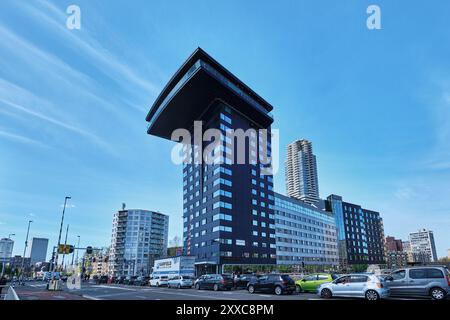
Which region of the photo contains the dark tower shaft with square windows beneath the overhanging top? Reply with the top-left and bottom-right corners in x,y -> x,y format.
183,102 -> 276,266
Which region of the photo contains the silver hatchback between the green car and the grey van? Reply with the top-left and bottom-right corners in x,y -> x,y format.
317,274 -> 389,300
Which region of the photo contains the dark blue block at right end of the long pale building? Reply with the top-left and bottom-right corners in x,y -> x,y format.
326,195 -> 385,269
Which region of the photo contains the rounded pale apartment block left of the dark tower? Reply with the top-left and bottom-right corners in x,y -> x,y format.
109,208 -> 169,276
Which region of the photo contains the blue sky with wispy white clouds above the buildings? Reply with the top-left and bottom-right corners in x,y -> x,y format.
0,0 -> 450,256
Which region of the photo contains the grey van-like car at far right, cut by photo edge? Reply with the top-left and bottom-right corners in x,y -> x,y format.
385,266 -> 450,300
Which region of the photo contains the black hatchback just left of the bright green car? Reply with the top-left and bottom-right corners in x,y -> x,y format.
247,274 -> 295,295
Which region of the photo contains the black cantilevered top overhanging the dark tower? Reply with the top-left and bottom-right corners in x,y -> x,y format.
146,48 -> 273,139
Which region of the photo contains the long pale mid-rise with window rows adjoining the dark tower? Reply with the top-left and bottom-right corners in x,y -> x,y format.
274,193 -> 339,269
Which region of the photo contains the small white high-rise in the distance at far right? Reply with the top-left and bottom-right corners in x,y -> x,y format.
409,229 -> 438,262
